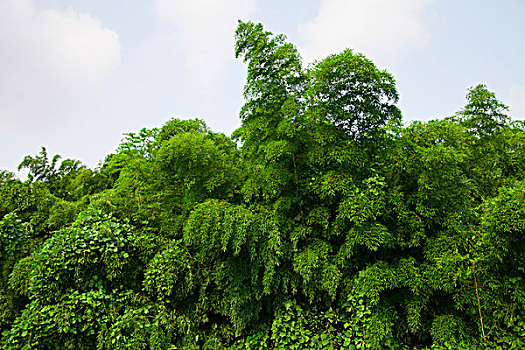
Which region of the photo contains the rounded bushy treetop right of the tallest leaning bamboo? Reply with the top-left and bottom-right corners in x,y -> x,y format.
306,49 -> 401,138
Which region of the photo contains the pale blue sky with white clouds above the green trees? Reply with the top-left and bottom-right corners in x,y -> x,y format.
0,0 -> 525,171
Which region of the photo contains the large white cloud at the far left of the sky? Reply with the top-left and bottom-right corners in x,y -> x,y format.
0,0 -> 120,127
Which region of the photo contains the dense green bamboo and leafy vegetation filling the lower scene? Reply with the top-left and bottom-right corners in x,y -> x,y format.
0,22 -> 525,349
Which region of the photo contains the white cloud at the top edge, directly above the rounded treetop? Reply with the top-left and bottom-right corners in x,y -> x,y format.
299,0 -> 433,62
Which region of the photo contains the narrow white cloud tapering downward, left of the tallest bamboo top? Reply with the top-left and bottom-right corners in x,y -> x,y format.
156,0 -> 256,87
